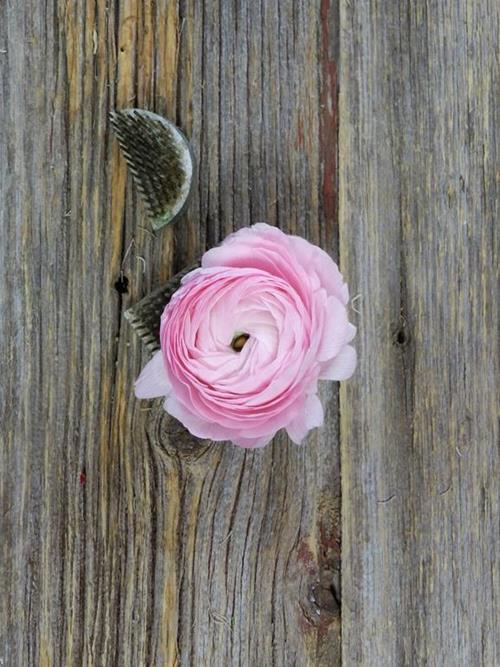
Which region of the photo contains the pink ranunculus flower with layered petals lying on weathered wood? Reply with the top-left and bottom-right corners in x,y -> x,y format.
135,223 -> 356,447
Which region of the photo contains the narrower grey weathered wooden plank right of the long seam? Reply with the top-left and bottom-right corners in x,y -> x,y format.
339,0 -> 500,667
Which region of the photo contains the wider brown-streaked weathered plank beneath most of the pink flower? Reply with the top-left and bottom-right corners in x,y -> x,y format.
0,0 -> 340,667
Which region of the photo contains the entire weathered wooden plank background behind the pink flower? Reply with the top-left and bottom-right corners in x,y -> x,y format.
0,0 -> 500,667
